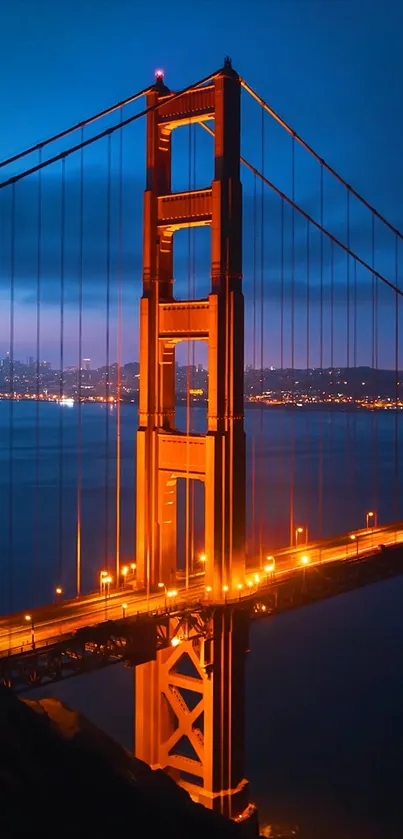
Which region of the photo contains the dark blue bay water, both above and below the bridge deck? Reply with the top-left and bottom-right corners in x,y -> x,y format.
0,402 -> 403,839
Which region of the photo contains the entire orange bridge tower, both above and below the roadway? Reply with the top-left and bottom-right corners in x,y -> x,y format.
135,59 -> 252,818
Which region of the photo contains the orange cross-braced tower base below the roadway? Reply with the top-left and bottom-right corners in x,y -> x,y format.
135,607 -> 249,819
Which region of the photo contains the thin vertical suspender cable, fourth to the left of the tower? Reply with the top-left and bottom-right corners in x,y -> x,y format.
56,158 -> 66,585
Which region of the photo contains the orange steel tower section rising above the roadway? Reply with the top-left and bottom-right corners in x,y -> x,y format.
136,59 -> 245,598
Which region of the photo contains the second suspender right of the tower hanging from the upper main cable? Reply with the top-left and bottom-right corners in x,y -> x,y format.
290,137 -> 295,545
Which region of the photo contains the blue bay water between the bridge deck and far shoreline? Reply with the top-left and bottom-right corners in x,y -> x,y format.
0,401 -> 403,613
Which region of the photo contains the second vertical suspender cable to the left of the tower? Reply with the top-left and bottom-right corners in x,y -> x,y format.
104,134 -> 112,572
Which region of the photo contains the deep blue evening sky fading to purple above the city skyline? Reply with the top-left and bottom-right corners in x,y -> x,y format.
0,0 -> 403,367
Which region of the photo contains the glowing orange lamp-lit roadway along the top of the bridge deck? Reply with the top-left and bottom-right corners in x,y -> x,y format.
0,522 -> 403,655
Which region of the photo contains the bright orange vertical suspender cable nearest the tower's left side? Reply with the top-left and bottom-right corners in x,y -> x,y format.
115,108 -> 123,582
